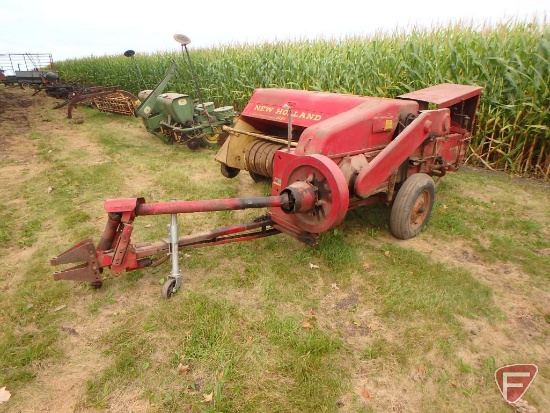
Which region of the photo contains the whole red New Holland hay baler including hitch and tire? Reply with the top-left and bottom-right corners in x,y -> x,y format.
51,84 -> 481,298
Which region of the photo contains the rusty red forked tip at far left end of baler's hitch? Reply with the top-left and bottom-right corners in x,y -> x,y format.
50,239 -> 101,283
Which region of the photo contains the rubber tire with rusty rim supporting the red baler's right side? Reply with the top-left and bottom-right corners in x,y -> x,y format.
390,173 -> 435,239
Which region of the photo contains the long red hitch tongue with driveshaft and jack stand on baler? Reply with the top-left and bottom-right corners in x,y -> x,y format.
50,183 -> 315,298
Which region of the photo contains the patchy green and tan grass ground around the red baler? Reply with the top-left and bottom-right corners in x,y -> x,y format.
0,88 -> 550,412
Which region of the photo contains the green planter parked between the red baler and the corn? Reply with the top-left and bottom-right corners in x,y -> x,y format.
135,34 -> 235,150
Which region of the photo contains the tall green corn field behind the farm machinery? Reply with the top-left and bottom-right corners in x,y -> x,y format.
57,18 -> 550,179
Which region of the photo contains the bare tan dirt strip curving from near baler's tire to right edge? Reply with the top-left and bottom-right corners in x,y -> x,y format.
388,234 -> 550,368
